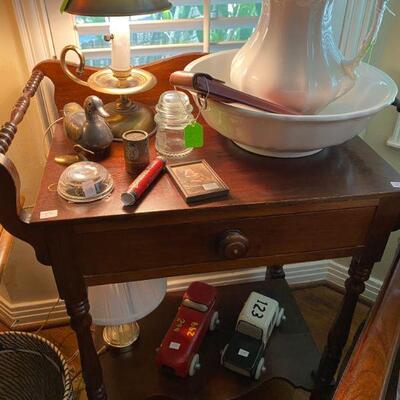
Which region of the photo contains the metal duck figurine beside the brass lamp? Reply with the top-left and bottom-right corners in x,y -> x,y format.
63,96 -> 113,161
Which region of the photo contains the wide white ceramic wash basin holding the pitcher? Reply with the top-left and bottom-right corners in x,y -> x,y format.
185,50 -> 398,157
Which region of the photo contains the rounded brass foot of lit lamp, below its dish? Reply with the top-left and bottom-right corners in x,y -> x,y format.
104,96 -> 156,140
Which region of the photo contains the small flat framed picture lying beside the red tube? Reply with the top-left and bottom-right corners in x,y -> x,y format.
167,160 -> 229,203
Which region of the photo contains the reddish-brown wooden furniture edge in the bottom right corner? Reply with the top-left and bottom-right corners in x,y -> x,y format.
334,248 -> 400,400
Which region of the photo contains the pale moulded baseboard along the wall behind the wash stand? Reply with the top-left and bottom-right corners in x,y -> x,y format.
0,260 -> 382,329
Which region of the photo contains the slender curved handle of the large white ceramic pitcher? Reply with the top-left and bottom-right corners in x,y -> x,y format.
342,0 -> 389,79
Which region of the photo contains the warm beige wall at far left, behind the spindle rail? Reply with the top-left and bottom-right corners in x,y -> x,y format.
0,0 -> 57,310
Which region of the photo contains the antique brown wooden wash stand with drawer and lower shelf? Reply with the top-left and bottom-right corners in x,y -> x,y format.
0,54 -> 400,400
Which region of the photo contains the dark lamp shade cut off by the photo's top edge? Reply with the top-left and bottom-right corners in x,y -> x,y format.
61,0 -> 171,17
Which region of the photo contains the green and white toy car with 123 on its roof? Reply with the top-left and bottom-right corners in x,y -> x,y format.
221,292 -> 285,379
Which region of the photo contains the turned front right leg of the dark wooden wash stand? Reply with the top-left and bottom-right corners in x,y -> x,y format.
312,257 -> 374,399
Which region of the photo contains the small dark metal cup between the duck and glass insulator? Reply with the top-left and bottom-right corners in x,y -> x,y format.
122,129 -> 150,175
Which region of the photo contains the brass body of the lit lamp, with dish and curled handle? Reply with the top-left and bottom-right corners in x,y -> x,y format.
60,45 -> 157,140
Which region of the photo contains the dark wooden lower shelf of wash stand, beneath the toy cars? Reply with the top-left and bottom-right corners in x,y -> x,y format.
96,279 -> 320,400
